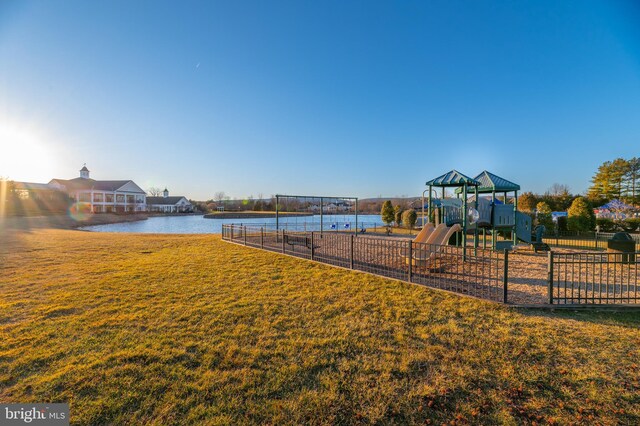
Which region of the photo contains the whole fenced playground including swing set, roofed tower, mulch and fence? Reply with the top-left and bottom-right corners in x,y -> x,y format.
222,175 -> 640,307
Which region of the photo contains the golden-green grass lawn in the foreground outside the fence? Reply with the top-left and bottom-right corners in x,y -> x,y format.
0,230 -> 640,424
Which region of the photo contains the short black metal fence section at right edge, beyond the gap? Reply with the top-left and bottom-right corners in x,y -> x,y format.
548,252 -> 640,305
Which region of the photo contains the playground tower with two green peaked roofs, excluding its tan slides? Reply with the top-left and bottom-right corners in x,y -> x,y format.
422,170 -> 532,256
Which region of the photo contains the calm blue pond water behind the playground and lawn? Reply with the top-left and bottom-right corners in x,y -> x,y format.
81,215 -> 382,234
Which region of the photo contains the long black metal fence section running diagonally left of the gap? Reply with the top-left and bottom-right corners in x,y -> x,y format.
222,225 -> 508,303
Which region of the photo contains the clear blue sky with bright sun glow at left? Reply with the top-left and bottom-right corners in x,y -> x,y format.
0,0 -> 640,199
